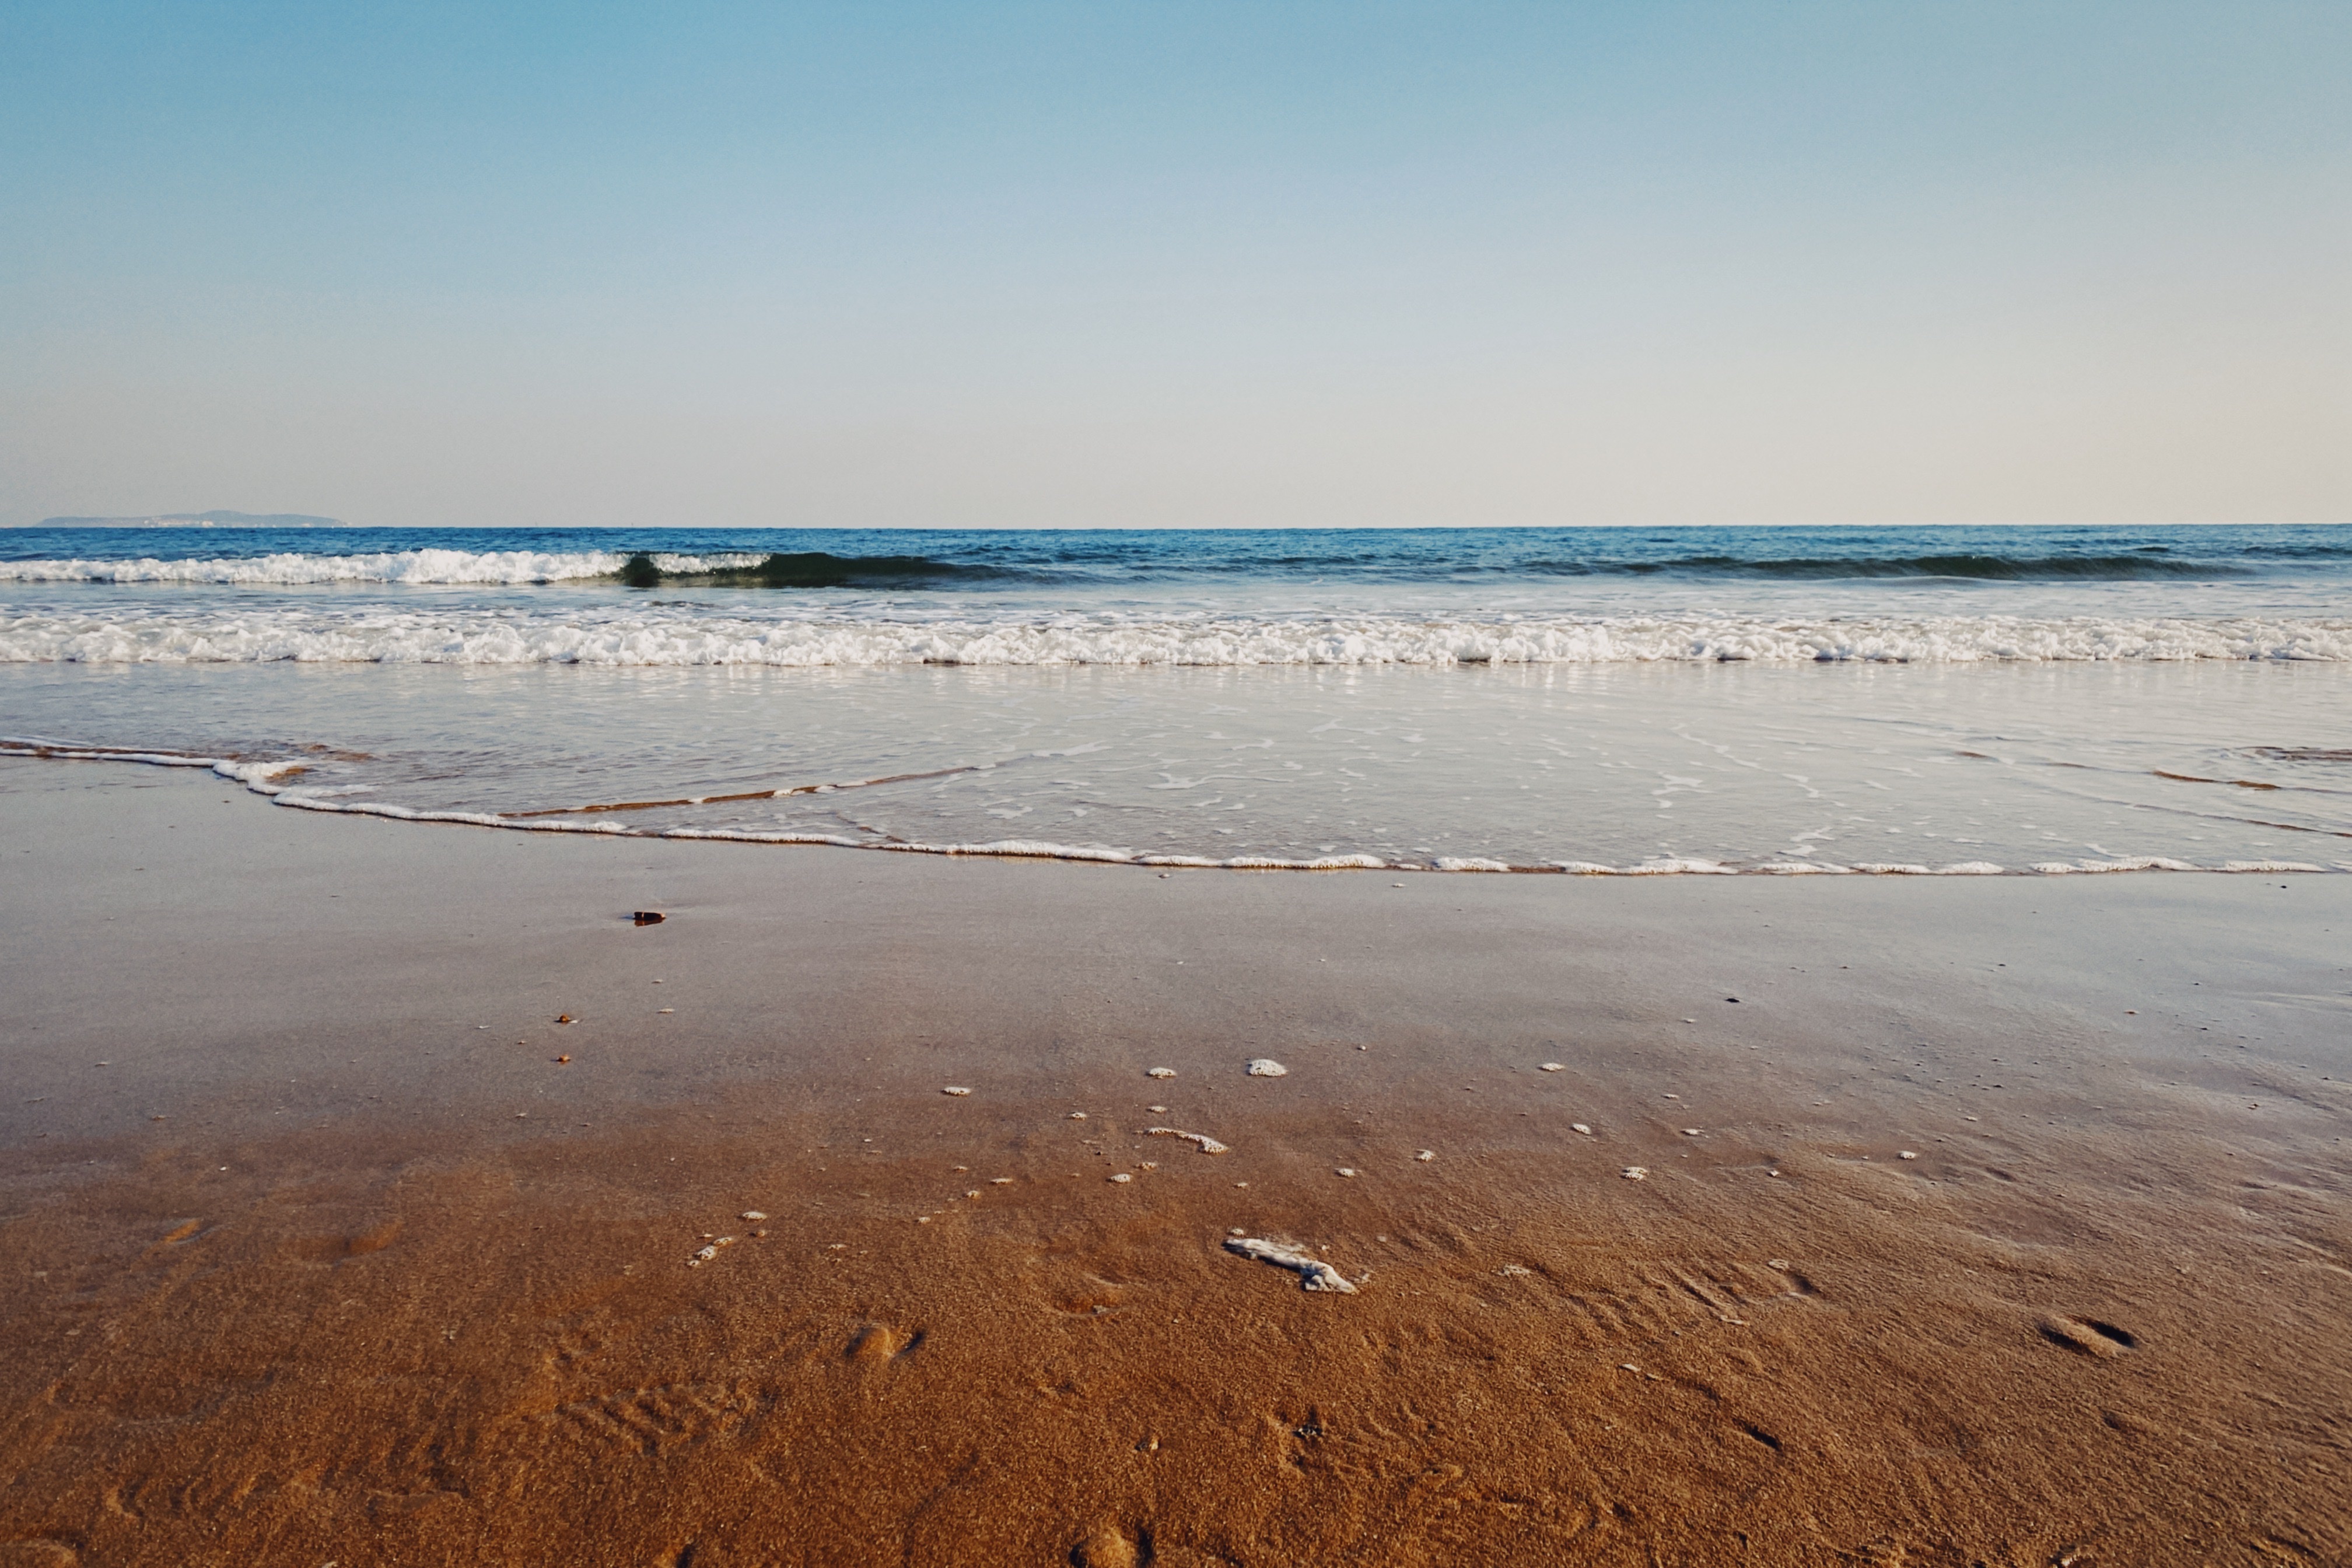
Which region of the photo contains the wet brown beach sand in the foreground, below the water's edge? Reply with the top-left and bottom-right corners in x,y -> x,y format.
0,764 -> 2352,1568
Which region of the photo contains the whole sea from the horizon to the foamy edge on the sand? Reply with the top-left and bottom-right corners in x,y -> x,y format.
0,527 -> 2352,874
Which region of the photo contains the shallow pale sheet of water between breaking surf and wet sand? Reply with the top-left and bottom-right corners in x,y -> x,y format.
0,663 -> 2352,872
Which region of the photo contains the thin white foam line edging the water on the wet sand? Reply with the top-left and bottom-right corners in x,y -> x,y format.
0,736 -> 2352,877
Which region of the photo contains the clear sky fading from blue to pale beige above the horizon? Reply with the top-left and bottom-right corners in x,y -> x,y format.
0,0 -> 2352,527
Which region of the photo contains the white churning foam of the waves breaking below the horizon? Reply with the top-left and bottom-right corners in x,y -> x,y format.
0,606 -> 2352,668
